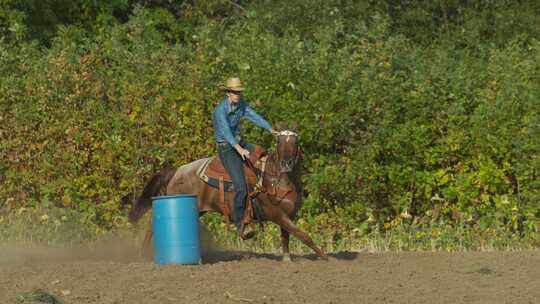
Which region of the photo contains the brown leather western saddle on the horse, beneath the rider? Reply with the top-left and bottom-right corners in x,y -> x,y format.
197,146 -> 267,225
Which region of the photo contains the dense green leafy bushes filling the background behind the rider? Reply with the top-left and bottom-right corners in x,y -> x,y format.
0,0 -> 540,249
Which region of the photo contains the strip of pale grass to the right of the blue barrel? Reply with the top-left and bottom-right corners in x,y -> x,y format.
199,216 -> 540,253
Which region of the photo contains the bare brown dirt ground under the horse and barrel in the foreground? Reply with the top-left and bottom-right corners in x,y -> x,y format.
0,244 -> 540,304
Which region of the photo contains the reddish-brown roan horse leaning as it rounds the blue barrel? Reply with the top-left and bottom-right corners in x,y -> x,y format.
129,130 -> 328,261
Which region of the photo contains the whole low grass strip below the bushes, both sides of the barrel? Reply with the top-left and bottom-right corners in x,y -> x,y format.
0,209 -> 540,254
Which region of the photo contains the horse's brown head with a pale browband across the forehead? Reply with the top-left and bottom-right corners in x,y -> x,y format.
276,130 -> 300,173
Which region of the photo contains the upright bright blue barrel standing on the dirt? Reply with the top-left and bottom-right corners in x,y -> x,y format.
152,195 -> 201,265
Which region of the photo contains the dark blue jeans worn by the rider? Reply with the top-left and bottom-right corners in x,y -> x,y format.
217,140 -> 255,228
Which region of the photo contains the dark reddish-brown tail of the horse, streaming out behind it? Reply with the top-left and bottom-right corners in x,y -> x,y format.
128,164 -> 176,223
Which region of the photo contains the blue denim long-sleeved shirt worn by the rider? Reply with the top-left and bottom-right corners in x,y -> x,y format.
213,98 -> 272,146
